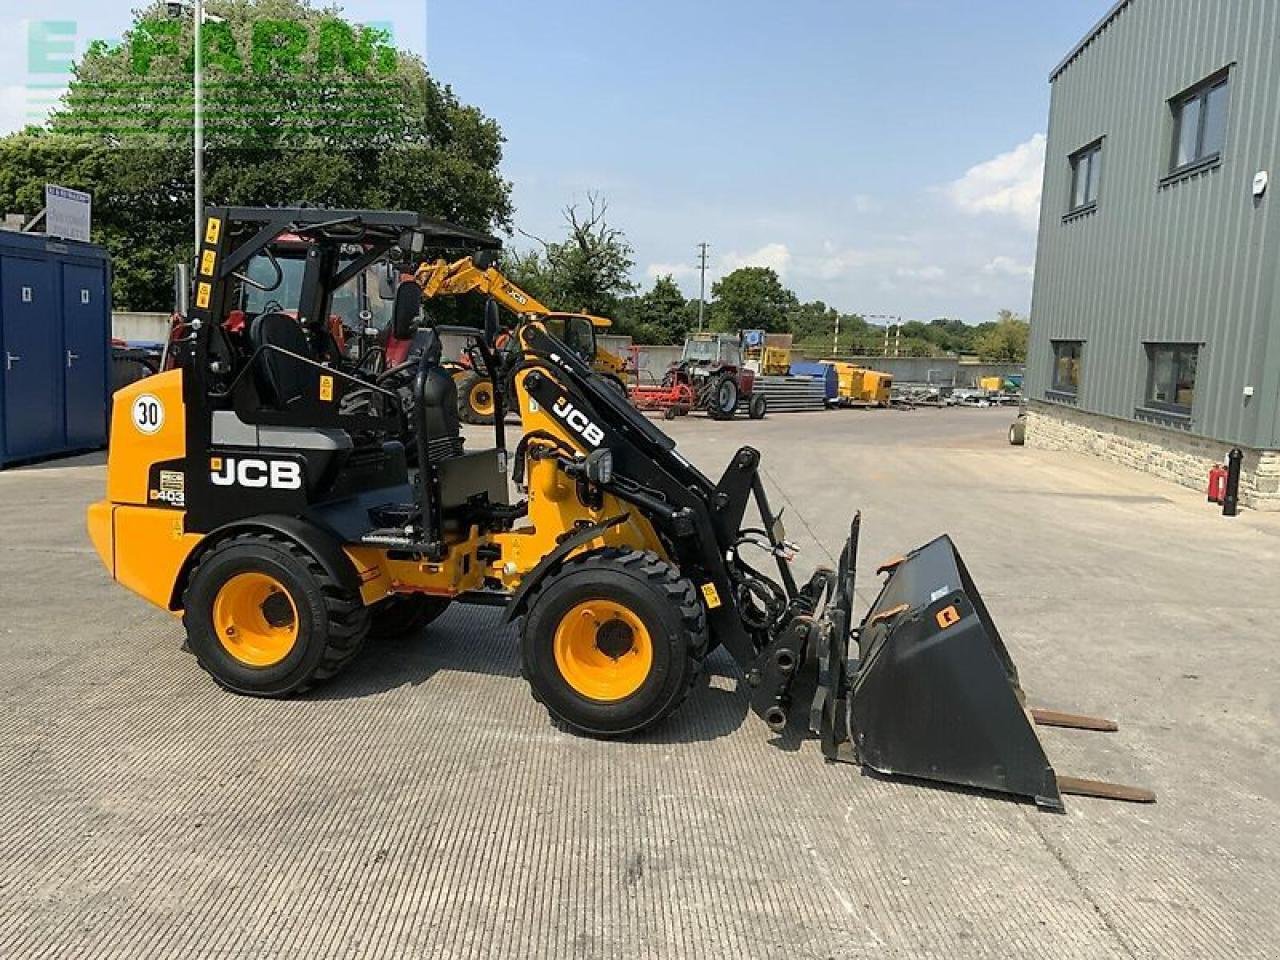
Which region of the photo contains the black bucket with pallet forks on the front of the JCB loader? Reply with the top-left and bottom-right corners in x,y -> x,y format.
810,527 -> 1155,810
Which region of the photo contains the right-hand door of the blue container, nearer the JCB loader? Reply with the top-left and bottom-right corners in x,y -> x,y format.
63,264 -> 109,447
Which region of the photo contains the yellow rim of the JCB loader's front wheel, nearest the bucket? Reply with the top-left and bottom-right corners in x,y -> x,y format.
554,600 -> 653,703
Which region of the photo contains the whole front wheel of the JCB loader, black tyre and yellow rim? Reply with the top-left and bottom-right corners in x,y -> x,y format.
521,549 -> 707,736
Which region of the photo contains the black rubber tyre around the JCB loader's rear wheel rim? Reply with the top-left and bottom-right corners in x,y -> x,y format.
182,532 -> 370,698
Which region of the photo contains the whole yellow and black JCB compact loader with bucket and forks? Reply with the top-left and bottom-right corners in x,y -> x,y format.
88,209 -> 1148,808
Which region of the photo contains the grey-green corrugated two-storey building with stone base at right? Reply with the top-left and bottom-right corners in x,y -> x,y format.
1027,0 -> 1280,509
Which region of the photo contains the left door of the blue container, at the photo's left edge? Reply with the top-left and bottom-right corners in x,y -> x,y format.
0,256 -> 64,458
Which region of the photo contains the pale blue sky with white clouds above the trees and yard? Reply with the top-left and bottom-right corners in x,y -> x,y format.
0,0 -> 1111,323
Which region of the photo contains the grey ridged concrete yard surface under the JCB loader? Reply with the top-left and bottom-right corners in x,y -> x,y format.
0,410 -> 1280,960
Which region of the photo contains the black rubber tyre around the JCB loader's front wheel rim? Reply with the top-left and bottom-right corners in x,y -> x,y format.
521,548 -> 708,737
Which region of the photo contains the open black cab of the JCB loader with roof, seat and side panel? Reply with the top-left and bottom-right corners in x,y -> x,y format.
183,207 -> 504,540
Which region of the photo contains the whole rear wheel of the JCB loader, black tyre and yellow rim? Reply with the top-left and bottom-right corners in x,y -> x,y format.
182,532 -> 369,696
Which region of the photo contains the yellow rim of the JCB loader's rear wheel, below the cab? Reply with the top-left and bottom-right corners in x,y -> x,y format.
214,573 -> 298,667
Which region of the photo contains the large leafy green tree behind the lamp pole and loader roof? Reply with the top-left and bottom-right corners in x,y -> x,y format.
0,0 -> 511,310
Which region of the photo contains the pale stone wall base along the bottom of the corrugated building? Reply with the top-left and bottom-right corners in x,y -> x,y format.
1027,401 -> 1280,512
